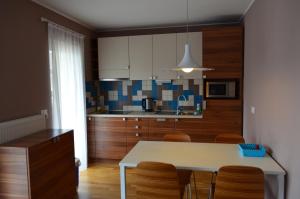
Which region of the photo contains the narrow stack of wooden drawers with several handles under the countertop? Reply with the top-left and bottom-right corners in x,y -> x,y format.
126,118 -> 149,152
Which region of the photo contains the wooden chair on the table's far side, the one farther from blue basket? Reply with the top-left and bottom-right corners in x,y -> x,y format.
164,133 -> 193,198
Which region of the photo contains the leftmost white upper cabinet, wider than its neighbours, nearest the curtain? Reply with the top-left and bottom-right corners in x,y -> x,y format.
98,37 -> 129,79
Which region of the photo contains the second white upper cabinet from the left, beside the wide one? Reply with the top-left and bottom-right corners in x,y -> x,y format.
129,35 -> 153,80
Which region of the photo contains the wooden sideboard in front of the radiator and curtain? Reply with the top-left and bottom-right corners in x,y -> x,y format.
0,129 -> 76,199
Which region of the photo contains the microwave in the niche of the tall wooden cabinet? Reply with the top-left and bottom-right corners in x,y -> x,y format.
204,79 -> 239,99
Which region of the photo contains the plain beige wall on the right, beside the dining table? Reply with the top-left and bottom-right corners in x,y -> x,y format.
244,0 -> 300,199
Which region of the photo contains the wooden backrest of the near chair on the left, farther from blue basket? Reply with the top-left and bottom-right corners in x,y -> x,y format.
135,162 -> 180,199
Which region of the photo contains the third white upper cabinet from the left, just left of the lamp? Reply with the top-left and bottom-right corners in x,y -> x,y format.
153,33 -> 177,80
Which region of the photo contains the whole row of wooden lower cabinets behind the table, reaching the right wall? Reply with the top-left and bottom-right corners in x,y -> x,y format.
88,117 -> 240,159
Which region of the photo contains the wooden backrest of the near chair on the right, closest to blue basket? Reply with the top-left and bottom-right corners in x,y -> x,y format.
214,166 -> 264,199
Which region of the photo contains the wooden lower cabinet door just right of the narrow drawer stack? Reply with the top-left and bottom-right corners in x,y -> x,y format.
149,118 -> 175,141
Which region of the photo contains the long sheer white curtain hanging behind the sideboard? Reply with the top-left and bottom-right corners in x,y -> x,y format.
48,23 -> 87,170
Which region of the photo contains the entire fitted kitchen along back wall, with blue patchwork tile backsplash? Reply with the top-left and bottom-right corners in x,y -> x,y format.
87,25 -> 243,161
